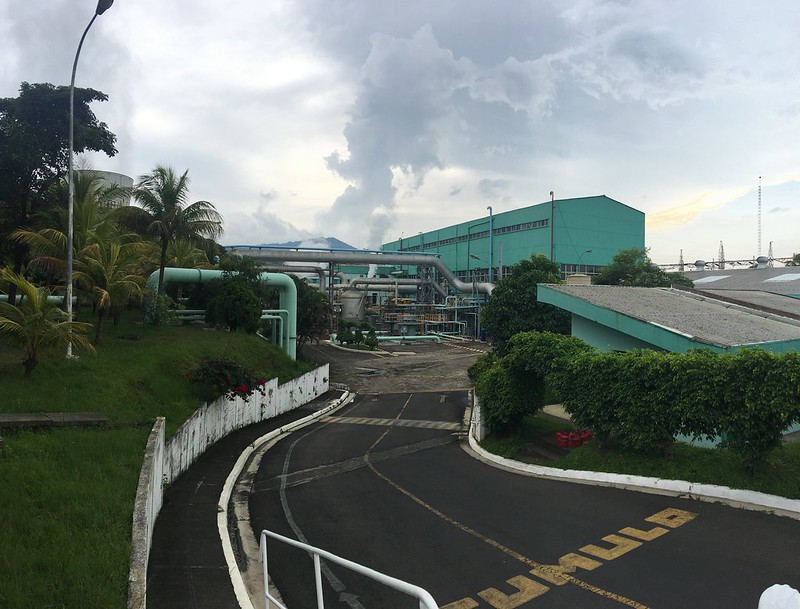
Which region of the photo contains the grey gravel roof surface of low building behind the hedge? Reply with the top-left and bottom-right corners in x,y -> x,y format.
547,285 -> 800,347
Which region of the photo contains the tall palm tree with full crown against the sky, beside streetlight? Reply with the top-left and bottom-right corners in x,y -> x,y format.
117,165 -> 222,294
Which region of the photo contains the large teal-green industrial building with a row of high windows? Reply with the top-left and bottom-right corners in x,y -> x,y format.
381,195 -> 644,281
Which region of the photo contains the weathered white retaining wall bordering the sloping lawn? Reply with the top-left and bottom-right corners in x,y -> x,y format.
128,364 -> 329,609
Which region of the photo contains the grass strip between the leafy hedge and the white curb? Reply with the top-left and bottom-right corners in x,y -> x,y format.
481,415 -> 800,499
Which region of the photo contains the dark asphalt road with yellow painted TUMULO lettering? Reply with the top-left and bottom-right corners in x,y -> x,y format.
242,390 -> 800,609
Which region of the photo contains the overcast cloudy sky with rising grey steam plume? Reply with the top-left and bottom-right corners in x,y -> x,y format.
0,0 -> 800,263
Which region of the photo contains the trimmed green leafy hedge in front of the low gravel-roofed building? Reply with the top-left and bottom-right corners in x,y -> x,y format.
470,332 -> 800,467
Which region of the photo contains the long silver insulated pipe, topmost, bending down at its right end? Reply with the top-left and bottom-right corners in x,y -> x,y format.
229,246 -> 494,294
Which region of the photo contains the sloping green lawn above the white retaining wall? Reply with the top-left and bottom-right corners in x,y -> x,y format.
0,311 -> 314,609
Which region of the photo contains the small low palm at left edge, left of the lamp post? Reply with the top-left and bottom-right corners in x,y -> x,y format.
0,268 -> 94,376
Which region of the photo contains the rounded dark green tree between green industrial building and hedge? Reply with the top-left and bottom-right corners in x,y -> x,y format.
481,254 -> 570,354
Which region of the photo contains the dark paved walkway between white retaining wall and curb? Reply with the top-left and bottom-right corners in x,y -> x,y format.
147,392 -> 341,609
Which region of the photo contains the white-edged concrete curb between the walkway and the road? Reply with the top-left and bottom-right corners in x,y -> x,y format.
217,391 -> 352,609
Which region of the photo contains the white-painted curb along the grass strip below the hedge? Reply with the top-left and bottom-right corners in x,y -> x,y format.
469,420 -> 800,520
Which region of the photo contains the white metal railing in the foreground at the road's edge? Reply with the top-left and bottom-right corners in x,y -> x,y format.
259,529 -> 439,609
